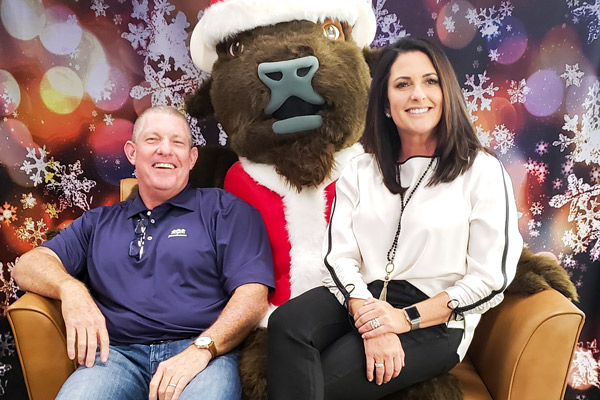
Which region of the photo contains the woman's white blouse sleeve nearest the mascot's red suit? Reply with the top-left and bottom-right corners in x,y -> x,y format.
323,159 -> 372,304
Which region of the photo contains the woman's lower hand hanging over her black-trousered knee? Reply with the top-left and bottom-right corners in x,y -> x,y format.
363,333 -> 404,385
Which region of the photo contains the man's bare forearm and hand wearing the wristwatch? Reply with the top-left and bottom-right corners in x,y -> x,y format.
149,283 -> 268,400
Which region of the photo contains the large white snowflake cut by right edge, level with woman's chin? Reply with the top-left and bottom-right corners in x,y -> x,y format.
552,81 -> 600,165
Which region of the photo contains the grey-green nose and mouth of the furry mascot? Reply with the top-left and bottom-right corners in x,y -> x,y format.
258,56 -> 325,134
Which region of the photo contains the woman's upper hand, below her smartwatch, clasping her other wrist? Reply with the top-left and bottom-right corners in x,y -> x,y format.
354,298 -> 410,339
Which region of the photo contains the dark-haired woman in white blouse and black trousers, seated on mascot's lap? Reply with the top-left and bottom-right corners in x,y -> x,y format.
267,38 -> 523,400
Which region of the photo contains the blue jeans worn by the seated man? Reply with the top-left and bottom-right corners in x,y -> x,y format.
56,339 -> 242,400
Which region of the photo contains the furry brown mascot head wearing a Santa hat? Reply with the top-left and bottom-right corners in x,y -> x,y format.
187,0 -> 376,191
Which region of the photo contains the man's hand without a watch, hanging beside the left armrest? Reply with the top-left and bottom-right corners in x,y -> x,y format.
60,281 -> 109,368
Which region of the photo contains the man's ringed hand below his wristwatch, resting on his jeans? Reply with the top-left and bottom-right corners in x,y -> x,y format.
148,346 -> 211,400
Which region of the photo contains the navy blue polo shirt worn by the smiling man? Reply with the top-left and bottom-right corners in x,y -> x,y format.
43,186 -> 274,344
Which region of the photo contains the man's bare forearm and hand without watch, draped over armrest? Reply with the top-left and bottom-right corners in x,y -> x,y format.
12,247 -> 109,367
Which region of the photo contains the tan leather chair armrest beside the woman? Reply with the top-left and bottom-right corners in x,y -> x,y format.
468,289 -> 585,400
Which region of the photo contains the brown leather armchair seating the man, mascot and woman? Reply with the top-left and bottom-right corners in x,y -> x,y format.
8,179 -> 585,400
